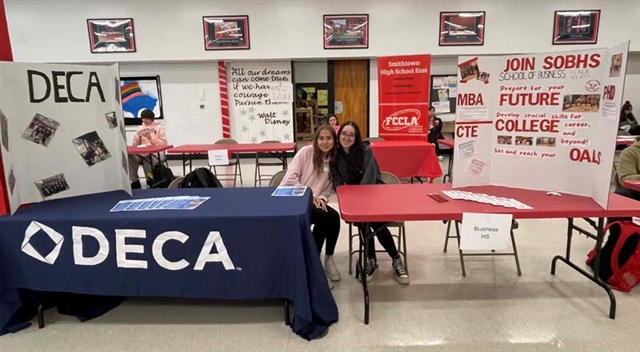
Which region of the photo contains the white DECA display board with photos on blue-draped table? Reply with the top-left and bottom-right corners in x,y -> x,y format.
0,63 -> 131,213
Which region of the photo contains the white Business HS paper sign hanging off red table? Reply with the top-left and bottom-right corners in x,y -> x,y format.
460,213 -> 513,250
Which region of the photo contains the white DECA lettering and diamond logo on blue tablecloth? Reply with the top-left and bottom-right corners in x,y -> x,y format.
21,221 -> 242,271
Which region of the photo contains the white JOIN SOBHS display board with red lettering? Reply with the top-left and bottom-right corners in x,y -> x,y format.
453,42 -> 629,207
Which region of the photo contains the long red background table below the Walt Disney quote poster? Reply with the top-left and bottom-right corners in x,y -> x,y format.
167,143 -> 297,174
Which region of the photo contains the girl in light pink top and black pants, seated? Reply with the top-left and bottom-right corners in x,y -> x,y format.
280,125 -> 340,288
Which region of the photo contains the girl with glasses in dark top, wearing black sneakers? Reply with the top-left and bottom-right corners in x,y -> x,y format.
331,121 -> 409,285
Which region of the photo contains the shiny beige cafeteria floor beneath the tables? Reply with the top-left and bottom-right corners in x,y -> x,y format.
0,159 -> 640,352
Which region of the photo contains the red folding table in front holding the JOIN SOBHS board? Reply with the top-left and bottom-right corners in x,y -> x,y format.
337,184 -> 640,324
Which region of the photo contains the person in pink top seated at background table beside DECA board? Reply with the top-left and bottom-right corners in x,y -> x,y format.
129,110 -> 167,189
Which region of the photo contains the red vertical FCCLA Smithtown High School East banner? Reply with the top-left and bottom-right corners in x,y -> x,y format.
378,55 -> 431,140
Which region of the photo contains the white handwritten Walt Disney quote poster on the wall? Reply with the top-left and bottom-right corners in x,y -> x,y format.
228,61 -> 294,143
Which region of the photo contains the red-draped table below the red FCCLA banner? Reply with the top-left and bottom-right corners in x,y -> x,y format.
371,141 -> 442,180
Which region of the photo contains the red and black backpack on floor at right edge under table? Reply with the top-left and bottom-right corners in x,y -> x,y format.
587,220 -> 640,292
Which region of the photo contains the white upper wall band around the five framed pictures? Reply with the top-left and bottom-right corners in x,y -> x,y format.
5,0 -> 640,62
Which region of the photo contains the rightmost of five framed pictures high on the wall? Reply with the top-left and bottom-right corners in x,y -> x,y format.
552,10 -> 600,45
